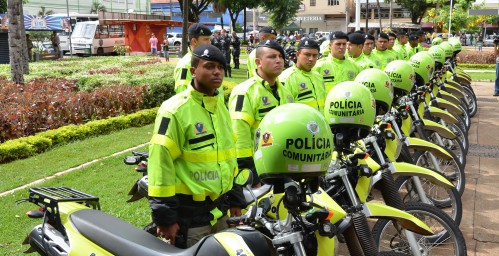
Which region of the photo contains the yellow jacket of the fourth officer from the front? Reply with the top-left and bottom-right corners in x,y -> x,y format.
313,54 -> 361,92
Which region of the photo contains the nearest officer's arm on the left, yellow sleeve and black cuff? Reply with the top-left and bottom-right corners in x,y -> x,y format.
148,113 -> 181,226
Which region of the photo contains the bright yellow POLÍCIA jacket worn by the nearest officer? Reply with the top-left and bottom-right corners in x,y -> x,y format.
148,85 -> 238,225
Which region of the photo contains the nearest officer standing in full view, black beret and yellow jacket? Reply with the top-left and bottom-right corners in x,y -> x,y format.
148,44 -> 248,248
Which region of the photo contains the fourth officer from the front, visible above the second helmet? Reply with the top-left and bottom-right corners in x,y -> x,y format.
314,31 -> 361,95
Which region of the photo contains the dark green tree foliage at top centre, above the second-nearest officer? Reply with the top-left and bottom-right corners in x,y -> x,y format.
261,0 -> 301,29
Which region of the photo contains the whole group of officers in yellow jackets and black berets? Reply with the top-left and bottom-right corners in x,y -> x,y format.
148,23 -> 472,247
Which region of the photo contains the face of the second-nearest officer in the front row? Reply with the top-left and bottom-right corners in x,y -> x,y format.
255,47 -> 284,78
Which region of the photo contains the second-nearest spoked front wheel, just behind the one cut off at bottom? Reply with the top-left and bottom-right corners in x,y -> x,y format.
396,176 -> 463,226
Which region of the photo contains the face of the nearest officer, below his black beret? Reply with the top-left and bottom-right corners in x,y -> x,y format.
191,59 -> 224,95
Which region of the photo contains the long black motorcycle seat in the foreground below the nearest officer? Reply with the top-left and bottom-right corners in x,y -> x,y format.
70,209 -> 208,256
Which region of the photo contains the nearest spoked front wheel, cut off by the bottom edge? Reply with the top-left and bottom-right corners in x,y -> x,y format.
372,203 -> 467,256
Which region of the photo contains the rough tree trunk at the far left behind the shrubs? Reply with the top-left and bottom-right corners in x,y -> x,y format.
7,0 -> 24,84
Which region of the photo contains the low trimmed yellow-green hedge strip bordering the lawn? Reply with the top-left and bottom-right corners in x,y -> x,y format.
0,108 -> 158,163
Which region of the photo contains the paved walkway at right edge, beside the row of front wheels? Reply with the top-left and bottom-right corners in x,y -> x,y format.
460,82 -> 499,256
